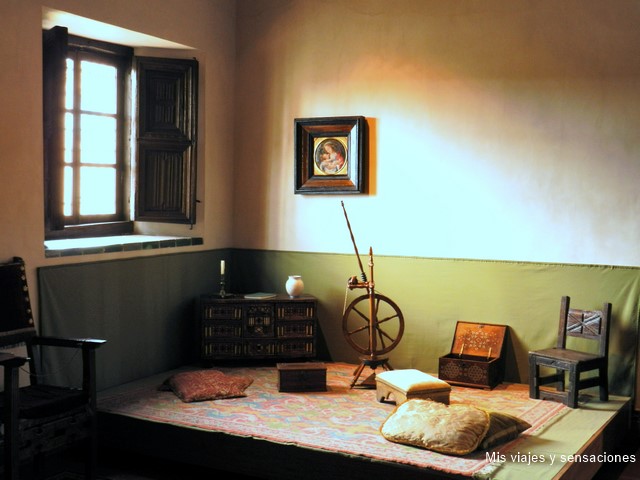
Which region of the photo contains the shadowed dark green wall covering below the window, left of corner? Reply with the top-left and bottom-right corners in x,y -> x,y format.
38,251 -> 231,389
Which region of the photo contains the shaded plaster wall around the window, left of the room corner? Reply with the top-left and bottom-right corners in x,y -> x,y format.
0,0 -> 235,284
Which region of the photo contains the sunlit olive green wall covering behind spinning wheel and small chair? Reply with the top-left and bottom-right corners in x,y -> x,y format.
232,250 -> 640,395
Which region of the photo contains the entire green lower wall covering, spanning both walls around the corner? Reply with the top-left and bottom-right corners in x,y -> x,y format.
39,249 -> 640,395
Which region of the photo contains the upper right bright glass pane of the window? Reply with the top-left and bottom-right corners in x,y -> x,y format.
80,61 -> 118,113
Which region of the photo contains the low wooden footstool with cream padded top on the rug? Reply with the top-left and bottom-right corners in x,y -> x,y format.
376,369 -> 451,405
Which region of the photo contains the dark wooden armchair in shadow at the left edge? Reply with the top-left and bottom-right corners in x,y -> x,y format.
0,257 -> 105,480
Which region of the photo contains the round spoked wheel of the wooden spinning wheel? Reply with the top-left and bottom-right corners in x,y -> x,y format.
342,293 -> 404,356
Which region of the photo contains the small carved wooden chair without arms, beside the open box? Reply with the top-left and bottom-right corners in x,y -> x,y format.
529,297 -> 611,408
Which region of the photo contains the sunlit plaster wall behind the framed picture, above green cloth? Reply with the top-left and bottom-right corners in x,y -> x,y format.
234,0 -> 640,265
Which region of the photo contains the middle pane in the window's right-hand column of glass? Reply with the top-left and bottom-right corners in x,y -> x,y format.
80,114 -> 116,165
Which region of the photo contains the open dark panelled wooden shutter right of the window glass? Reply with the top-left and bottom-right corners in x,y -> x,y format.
135,57 -> 198,224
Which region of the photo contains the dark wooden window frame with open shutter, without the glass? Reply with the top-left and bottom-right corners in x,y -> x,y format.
43,27 -> 198,240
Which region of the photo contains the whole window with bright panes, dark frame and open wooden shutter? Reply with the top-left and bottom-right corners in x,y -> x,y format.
43,27 -> 198,239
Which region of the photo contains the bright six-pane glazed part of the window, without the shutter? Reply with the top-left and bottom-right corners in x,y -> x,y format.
62,37 -> 132,225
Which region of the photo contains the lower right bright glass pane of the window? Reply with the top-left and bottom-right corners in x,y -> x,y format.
80,167 -> 116,215
